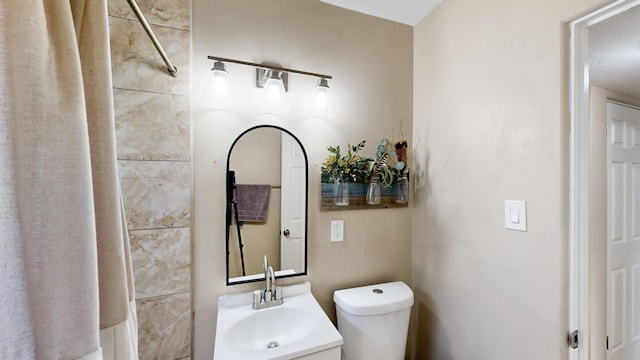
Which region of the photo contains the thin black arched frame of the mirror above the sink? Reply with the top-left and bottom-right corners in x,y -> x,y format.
225,124 -> 309,286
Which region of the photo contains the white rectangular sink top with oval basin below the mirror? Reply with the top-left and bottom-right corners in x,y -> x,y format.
214,282 -> 342,360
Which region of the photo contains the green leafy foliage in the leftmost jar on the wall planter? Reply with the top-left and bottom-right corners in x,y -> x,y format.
321,140 -> 373,183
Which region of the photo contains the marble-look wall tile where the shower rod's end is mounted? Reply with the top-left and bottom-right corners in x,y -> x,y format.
109,16 -> 190,95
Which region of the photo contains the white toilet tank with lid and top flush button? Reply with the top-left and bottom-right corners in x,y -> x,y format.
333,281 -> 413,360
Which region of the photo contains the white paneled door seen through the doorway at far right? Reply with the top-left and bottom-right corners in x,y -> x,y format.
607,103 -> 640,360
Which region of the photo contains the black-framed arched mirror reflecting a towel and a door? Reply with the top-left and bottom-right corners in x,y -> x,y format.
226,125 -> 308,285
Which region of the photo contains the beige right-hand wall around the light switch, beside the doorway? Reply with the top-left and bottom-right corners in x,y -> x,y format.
413,0 -> 607,360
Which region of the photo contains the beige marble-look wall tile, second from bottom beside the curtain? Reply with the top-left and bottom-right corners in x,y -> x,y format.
129,227 -> 191,299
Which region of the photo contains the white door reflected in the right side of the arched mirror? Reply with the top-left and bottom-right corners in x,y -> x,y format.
280,132 -> 307,273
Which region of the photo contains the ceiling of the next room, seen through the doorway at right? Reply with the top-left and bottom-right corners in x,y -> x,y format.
589,7 -> 640,98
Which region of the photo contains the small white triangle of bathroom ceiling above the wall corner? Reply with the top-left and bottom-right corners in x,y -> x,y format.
320,0 -> 442,26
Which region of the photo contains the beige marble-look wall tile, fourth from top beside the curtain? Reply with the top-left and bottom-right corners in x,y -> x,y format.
118,160 -> 191,230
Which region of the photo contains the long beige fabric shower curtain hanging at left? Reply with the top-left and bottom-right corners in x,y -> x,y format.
0,0 -> 137,360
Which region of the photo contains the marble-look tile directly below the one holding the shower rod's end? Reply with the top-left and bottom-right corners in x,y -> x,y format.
113,89 -> 190,161
